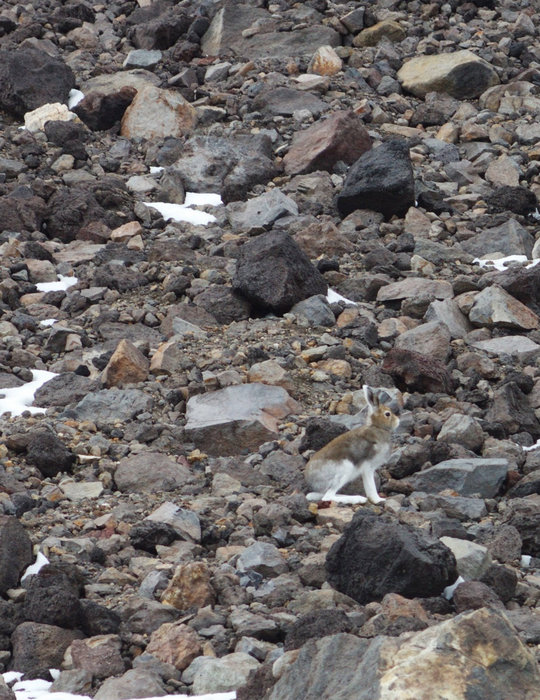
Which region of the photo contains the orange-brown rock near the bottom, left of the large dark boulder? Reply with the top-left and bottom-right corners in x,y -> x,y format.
161,561 -> 215,610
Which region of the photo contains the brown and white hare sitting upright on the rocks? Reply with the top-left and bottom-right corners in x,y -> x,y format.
305,385 -> 399,503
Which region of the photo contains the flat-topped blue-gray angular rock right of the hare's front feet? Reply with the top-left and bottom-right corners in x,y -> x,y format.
407,457 -> 509,498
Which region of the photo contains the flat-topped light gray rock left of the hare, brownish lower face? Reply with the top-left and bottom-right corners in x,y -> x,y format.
185,382 -> 299,455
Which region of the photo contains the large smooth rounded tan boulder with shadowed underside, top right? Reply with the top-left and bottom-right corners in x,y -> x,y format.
397,50 -> 499,99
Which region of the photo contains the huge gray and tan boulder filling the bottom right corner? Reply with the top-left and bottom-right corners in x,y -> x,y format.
264,608 -> 540,700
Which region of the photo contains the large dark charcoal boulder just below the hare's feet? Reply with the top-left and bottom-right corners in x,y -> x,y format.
326,510 -> 457,604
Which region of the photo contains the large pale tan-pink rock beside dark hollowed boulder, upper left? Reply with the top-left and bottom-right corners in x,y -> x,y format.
120,85 -> 197,139
